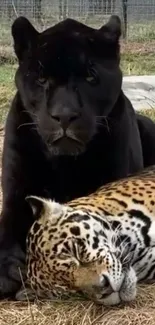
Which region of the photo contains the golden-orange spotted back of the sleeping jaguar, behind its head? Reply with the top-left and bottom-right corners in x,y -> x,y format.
67,166 -> 155,217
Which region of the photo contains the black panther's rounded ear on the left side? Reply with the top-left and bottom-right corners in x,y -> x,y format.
12,17 -> 39,61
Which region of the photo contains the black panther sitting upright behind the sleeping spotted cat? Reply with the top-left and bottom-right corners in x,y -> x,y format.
0,16 -> 155,298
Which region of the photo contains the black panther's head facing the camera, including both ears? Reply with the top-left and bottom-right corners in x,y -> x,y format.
12,16 -> 122,155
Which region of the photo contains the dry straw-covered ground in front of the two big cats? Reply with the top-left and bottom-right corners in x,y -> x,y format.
0,128 -> 155,325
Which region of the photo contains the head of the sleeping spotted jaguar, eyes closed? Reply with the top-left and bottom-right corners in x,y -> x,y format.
24,196 -> 136,304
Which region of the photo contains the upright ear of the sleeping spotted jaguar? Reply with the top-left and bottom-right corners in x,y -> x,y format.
25,196 -> 45,220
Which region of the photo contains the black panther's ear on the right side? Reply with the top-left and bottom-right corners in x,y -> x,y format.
99,15 -> 122,42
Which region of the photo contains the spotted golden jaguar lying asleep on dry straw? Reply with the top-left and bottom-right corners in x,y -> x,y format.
18,166 -> 155,305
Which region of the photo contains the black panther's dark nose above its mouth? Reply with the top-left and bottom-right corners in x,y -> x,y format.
51,112 -> 80,130
